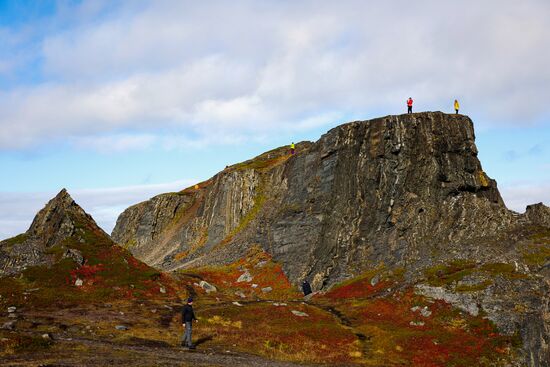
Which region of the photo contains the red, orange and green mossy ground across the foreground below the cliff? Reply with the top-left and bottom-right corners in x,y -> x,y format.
0,239 -> 528,366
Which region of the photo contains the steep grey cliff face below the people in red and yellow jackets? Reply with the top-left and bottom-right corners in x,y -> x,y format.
112,113 -> 513,288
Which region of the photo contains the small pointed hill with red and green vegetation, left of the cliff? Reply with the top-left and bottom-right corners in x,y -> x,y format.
0,190 -> 174,308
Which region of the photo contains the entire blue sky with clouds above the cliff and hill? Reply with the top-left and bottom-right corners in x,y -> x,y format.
0,0 -> 550,239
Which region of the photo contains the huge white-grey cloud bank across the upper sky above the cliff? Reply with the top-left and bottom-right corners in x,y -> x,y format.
0,0 -> 550,149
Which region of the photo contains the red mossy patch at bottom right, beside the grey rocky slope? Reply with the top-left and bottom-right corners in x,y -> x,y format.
337,289 -> 514,366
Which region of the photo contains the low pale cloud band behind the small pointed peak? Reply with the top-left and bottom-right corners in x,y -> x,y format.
0,179 -> 196,239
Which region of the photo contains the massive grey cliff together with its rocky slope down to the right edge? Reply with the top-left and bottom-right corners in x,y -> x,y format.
112,112 -> 550,366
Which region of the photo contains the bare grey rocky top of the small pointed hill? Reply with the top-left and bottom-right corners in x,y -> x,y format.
0,189 -> 108,276
